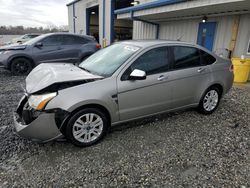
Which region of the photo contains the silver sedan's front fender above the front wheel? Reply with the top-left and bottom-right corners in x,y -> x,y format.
46,77 -> 119,122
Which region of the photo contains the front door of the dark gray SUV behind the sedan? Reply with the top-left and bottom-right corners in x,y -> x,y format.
33,35 -> 62,63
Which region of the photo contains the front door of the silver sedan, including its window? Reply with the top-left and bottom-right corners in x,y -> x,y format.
117,47 -> 171,120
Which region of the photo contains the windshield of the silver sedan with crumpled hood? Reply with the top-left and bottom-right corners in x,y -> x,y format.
79,43 -> 139,77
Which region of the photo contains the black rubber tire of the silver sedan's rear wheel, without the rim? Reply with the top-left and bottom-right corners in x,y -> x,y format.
198,86 -> 221,115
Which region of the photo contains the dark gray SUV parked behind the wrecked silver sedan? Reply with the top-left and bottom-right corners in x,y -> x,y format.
0,33 -> 101,75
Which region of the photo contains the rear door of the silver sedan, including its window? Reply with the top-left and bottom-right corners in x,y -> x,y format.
171,46 -> 211,108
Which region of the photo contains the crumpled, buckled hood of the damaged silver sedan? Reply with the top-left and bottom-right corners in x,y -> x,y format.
26,63 -> 103,94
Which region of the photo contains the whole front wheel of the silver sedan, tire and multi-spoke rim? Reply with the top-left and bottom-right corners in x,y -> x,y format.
65,108 -> 109,147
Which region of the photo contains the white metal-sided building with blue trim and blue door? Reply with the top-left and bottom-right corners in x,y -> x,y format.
67,0 -> 250,58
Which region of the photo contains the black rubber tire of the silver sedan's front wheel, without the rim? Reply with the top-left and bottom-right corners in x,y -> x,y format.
65,108 -> 109,147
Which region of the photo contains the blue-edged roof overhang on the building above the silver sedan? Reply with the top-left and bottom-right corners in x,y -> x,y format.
115,0 -> 250,22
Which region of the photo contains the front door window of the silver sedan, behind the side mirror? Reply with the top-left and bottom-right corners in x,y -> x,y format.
131,47 -> 169,75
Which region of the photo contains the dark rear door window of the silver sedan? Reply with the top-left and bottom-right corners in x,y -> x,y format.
173,46 -> 201,69
